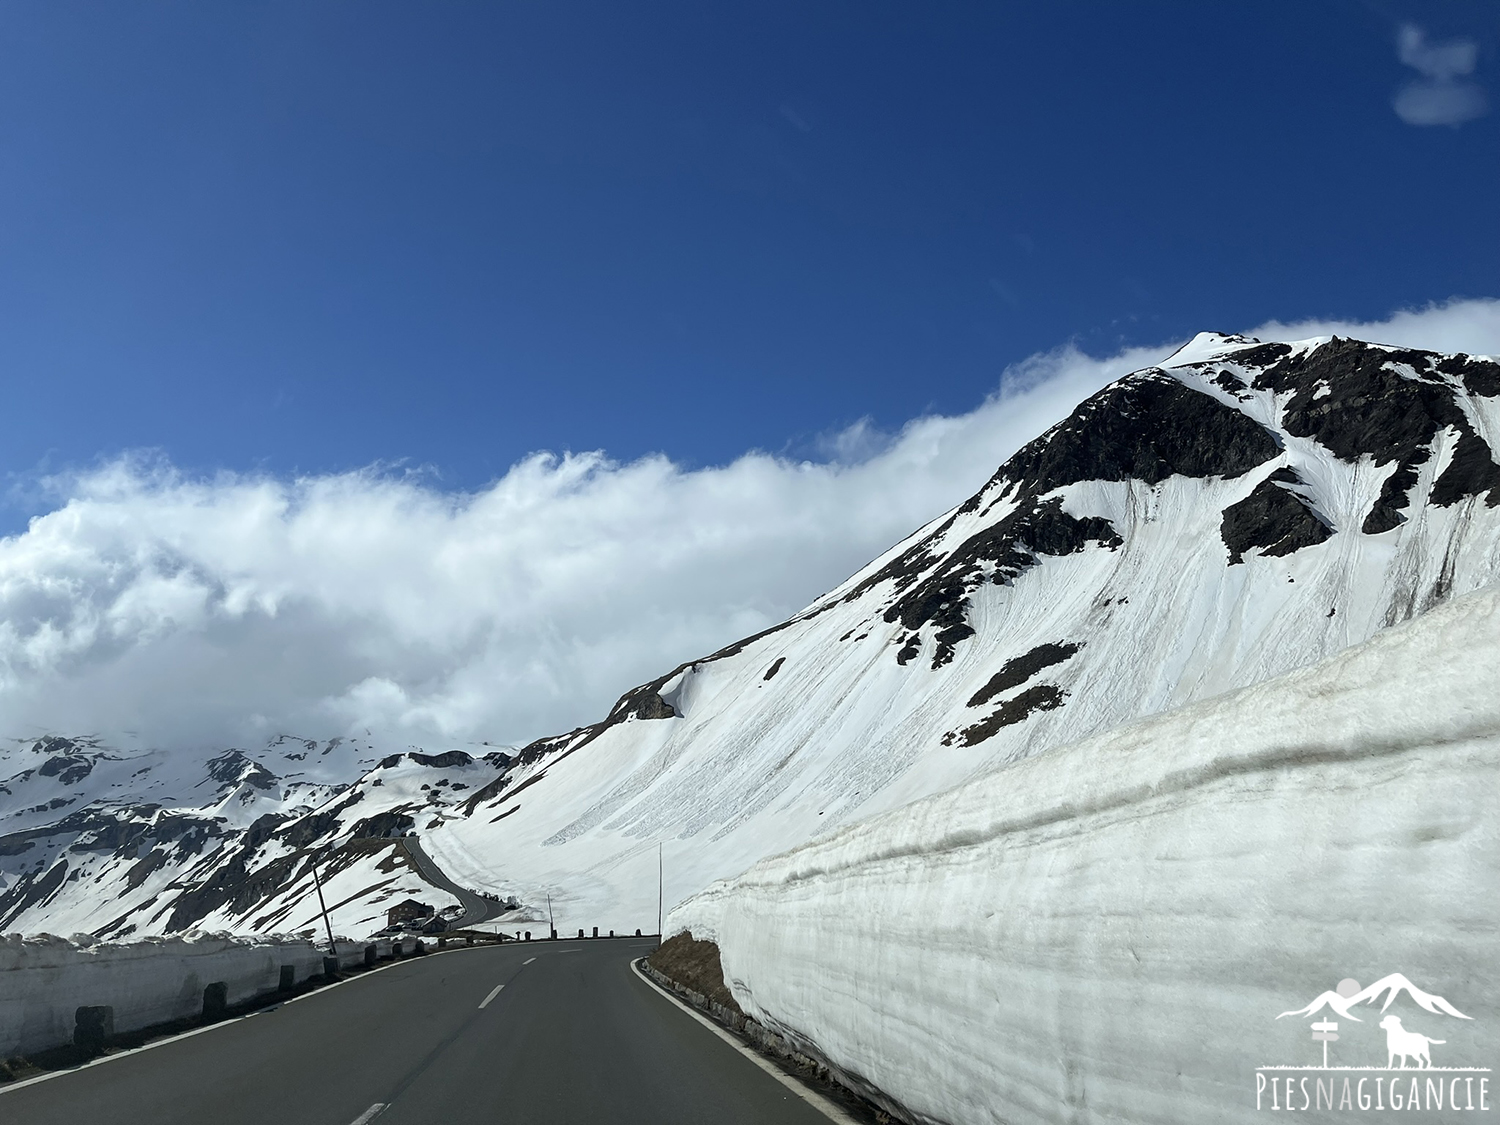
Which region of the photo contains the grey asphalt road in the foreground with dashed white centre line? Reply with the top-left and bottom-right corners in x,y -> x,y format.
0,939 -> 828,1125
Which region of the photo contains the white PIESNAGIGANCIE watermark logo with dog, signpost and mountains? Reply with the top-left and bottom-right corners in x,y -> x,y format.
1256,972 -> 1493,1113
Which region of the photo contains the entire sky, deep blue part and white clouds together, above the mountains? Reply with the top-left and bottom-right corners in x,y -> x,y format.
0,0 -> 1500,750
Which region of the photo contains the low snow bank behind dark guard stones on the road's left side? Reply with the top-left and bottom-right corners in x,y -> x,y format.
0,935 -> 410,1058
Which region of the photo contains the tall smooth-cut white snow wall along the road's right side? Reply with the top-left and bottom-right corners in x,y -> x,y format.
668,590 -> 1500,1125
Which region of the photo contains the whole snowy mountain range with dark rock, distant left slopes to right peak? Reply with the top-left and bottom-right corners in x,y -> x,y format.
0,335 -> 1500,933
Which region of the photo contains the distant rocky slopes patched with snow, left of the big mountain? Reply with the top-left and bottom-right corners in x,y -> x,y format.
0,737 -> 509,938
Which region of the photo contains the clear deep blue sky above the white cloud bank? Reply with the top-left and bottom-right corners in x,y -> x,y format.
0,0 -> 1500,489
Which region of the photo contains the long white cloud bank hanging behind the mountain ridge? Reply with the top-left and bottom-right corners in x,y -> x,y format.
0,302 -> 1500,759
